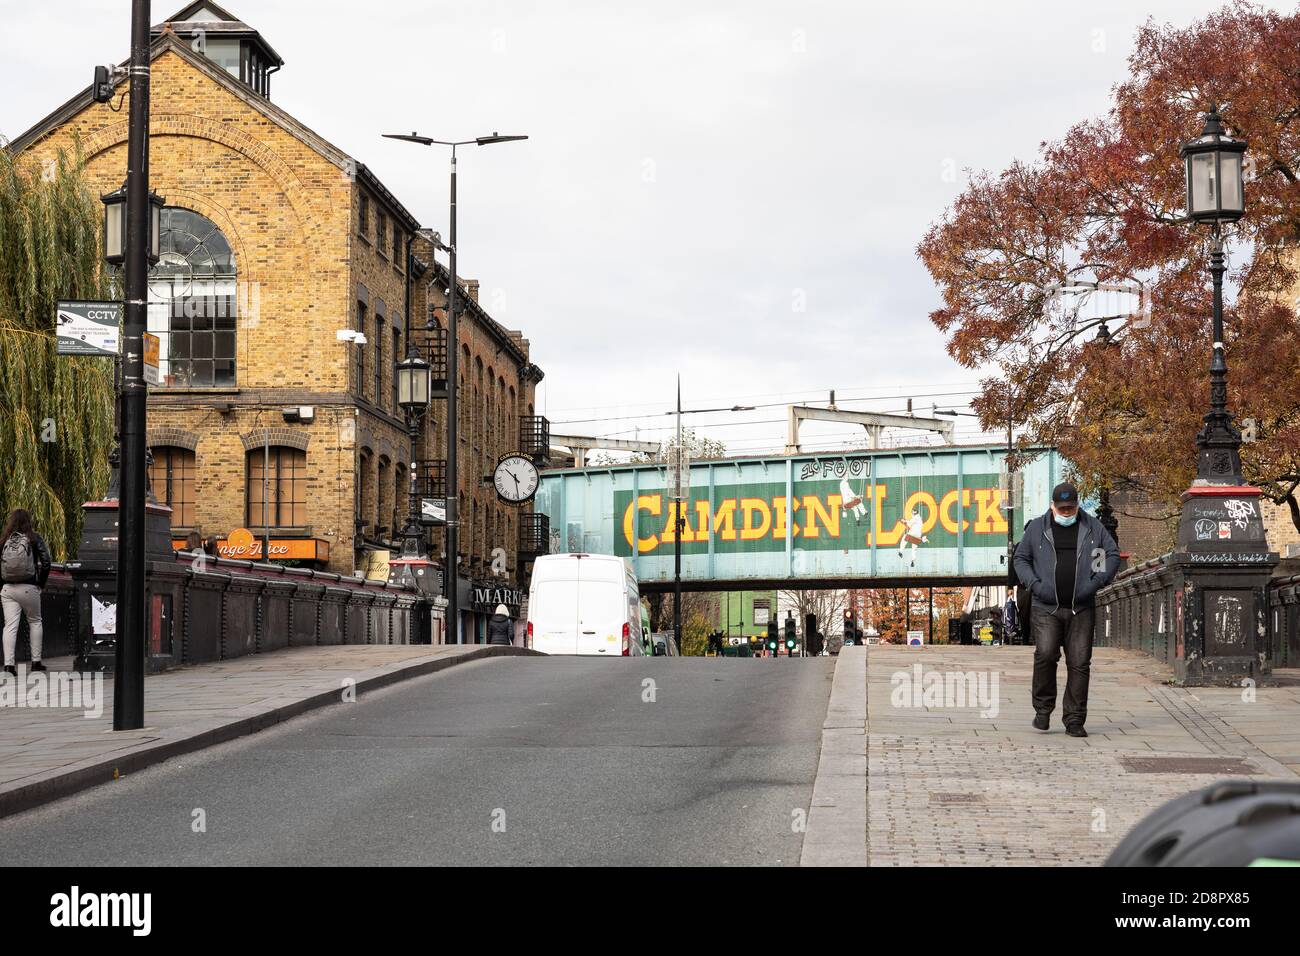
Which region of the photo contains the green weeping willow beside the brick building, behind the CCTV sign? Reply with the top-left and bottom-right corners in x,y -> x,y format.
0,150 -> 113,559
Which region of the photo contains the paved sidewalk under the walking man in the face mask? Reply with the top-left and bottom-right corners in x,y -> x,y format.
867,645 -> 1300,866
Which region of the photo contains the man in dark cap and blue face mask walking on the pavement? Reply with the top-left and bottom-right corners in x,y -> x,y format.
1015,481 -> 1119,737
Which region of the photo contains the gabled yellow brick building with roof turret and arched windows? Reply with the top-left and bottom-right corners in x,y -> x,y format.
10,1 -> 542,640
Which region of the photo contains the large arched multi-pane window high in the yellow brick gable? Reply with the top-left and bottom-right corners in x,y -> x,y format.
148,207 -> 237,388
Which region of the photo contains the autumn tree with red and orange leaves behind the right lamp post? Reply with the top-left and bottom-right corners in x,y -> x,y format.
918,3 -> 1300,528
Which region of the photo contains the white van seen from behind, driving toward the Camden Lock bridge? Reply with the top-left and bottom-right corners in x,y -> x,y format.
528,554 -> 646,657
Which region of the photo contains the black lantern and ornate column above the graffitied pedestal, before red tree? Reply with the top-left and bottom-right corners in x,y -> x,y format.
1179,108 -> 1245,485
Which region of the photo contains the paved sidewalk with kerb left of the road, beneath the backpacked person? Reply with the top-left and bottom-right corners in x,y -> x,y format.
0,644 -> 534,817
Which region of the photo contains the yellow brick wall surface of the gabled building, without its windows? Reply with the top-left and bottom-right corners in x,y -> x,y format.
25,39 -> 534,575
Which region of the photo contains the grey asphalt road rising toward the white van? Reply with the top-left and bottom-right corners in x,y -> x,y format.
0,657 -> 835,866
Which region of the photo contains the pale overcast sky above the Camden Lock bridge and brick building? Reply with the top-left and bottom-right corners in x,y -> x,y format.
0,0 -> 1291,453
